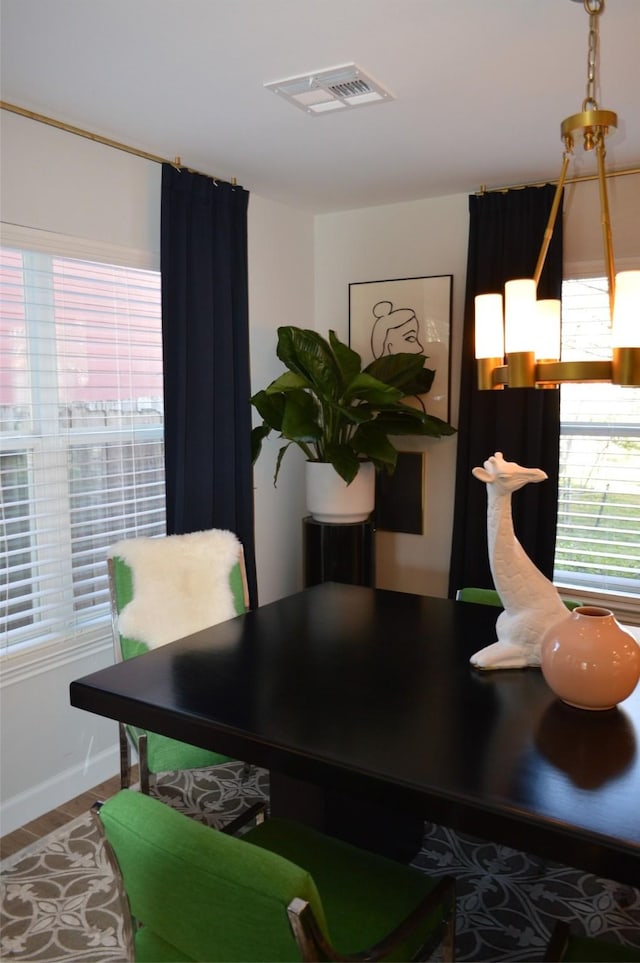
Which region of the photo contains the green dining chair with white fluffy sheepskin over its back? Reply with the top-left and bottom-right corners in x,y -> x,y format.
107,529 -> 249,795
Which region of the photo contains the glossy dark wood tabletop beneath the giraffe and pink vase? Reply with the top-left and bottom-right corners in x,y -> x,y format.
71,583 -> 640,886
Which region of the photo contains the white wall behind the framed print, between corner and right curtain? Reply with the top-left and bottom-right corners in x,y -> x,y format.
315,194 -> 468,596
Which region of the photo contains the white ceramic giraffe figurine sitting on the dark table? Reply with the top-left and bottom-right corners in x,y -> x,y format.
471,451 -> 569,669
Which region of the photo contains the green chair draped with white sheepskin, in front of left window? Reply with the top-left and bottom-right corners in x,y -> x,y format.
107,529 -> 248,794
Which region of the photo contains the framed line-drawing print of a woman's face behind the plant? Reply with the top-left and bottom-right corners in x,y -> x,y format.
349,274 -> 453,421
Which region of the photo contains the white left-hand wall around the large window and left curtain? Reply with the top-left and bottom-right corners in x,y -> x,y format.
0,111 -> 313,833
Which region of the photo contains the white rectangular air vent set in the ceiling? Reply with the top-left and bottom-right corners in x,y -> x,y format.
264,64 -> 394,114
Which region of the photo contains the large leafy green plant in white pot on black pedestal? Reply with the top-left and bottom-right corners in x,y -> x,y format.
251,326 -> 455,521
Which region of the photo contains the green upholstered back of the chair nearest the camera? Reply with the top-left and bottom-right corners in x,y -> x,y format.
99,790 -> 326,963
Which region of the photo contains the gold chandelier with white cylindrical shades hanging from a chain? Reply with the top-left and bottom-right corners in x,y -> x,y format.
475,0 -> 640,390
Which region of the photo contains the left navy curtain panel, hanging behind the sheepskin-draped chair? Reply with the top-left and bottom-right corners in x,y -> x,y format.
160,164 -> 257,606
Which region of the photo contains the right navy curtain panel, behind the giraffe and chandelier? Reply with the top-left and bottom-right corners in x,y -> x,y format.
449,185 -> 562,598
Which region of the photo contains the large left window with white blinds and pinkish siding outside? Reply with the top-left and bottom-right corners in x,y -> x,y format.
0,241 -> 165,653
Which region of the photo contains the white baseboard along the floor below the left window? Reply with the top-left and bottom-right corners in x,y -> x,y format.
0,747 -> 120,836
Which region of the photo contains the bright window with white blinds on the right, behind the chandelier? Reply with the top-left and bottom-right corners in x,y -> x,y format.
554,278 -> 640,608
